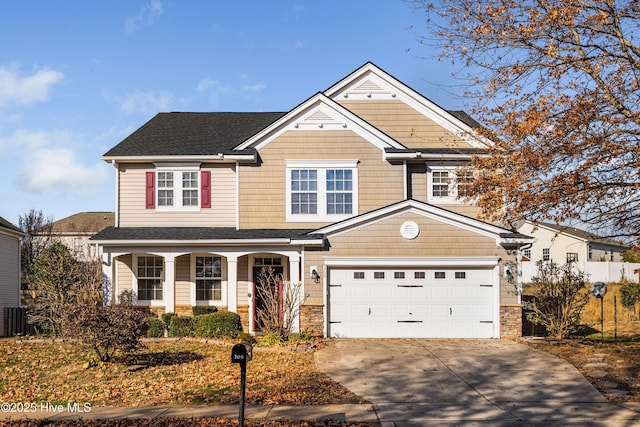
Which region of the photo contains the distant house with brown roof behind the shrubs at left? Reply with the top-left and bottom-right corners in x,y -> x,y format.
47,212 -> 115,261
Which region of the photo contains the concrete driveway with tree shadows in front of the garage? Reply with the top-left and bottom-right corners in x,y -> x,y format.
316,339 -> 640,427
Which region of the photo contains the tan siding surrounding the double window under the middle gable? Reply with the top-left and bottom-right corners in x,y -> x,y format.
239,130 -> 404,228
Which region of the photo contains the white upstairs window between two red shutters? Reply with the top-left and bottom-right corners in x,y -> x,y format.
156,166 -> 200,210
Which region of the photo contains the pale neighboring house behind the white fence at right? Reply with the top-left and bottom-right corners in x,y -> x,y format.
518,221 -> 630,264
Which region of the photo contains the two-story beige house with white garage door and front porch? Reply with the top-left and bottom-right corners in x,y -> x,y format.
92,63 -> 531,338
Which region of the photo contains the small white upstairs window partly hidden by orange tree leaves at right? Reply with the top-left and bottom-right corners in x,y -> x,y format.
427,166 -> 473,203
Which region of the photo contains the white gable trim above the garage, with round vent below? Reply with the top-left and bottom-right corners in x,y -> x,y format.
312,200 -> 509,245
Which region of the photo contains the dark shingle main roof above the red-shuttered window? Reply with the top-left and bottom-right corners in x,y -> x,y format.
104,112 -> 285,157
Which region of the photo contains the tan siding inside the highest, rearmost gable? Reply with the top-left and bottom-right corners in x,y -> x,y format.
338,99 -> 470,148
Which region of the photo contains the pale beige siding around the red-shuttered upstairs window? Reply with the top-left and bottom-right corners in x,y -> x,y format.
118,164 -> 236,227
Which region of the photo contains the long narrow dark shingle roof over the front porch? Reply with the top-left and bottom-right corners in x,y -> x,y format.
91,227 -> 322,241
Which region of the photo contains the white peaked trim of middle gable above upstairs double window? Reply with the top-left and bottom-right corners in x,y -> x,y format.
235,93 -> 405,150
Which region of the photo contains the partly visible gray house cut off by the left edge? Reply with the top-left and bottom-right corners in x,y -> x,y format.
0,217 -> 24,336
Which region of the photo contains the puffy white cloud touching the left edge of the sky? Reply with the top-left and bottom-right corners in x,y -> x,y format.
0,66 -> 64,108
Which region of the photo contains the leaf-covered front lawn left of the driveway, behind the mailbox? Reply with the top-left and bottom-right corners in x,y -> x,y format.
0,339 -> 363,407
